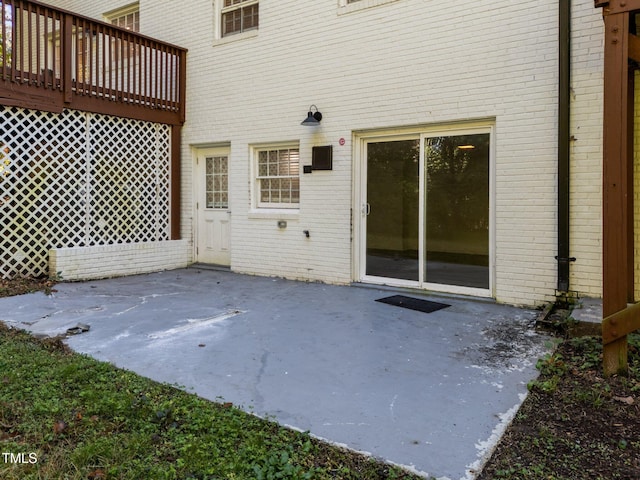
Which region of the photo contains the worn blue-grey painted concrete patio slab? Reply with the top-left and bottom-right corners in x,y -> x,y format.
0,268 -> 547,479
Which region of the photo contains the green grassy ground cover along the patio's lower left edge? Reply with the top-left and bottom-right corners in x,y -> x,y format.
0,323 -> 418,480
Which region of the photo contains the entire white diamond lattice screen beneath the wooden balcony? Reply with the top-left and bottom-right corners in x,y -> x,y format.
0,107 -> 170,278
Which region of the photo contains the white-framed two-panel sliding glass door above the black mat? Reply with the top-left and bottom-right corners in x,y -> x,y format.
361,128 -> 491,293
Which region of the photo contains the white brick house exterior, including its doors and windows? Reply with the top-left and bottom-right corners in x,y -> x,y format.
17,0 -> 608,306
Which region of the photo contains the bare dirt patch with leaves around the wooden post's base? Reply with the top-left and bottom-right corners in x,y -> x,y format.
478,335 -> 640,480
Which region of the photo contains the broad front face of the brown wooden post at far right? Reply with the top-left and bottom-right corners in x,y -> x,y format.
602,10 -> 640,375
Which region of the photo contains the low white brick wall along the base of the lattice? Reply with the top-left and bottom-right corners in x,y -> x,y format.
49,240 -> 188,280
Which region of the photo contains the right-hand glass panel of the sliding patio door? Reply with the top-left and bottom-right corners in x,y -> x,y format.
424,133 -> 490,289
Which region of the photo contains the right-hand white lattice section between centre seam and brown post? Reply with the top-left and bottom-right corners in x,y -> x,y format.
89,115 -> 169,244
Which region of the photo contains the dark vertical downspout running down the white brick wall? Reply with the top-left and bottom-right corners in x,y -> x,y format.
556,0 -> 575,294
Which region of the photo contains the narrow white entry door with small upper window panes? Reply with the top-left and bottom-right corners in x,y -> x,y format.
196,148 -> 231,266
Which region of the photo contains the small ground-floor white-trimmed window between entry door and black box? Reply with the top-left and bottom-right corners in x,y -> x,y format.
254,145 -> 300,208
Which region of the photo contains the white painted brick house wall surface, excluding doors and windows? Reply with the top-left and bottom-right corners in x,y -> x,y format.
47,0 -> 602,305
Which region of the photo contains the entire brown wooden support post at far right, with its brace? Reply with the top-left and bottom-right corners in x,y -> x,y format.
595,0 -> 640,375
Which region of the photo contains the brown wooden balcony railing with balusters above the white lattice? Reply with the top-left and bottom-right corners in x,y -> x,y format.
0,0 -> 186,125
